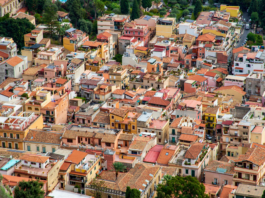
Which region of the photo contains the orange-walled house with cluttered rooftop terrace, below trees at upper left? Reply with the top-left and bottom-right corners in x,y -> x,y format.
63,28 -> 88,52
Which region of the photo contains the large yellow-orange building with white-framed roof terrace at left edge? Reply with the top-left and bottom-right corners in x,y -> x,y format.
0,112 -> 43,150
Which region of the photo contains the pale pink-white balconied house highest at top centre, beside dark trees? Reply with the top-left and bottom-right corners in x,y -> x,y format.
97,14 -> 130,34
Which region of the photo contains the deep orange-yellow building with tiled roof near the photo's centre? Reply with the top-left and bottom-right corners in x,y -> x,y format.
110,109 -> 139,134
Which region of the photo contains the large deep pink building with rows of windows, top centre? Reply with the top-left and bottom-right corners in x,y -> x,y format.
123,21 -> 150,47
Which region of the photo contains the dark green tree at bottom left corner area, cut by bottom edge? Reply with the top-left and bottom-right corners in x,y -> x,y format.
14,181 -> 44,198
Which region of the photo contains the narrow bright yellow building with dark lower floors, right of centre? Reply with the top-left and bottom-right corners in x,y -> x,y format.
204,106 -> 219,135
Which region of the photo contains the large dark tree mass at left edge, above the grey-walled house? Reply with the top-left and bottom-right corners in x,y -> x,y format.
0,18 -> 35,49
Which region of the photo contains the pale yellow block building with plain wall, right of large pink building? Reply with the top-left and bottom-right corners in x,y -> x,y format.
156,17 -> 176,38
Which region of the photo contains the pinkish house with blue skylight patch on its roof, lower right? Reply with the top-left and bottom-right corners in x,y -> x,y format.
204,160 -> 235,186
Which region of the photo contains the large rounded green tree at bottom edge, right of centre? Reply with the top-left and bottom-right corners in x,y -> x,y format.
157,176 -> 208,198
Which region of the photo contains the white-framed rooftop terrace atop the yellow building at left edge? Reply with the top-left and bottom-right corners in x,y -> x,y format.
0,112 -> 39,131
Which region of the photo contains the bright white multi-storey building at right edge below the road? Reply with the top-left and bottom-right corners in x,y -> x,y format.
232,52 -> 265,75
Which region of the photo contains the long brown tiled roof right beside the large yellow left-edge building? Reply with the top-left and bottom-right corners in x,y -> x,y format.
24,130 -> 62,145
